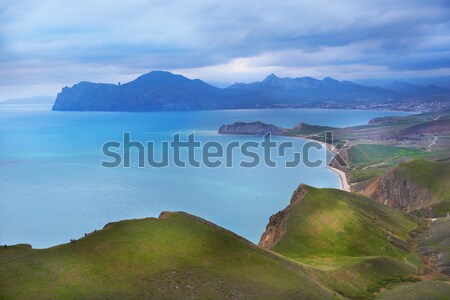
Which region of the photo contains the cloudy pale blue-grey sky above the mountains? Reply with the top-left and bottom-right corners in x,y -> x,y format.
0,0 -> 450,99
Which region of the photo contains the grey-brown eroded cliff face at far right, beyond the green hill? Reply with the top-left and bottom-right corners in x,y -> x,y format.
353,169 -> 436,217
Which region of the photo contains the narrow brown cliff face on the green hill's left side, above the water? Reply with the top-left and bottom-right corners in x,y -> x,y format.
258,184 -> 308,249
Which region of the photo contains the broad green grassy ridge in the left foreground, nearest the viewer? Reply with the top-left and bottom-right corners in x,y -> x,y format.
0,213 -> 333,299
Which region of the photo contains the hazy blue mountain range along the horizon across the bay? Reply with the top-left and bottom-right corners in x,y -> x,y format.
53,71 -> 450,111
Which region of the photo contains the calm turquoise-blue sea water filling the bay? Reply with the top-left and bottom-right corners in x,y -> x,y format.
0,106 -> 407,248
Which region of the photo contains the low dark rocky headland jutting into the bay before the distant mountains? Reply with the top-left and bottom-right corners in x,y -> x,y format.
219,122 -> 286,135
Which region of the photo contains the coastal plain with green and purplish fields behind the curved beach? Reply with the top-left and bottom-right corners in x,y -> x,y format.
342,111 -> 450,182
